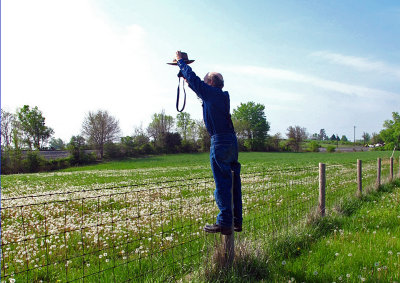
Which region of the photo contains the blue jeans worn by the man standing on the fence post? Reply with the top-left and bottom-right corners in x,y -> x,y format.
210,134 -> 243,227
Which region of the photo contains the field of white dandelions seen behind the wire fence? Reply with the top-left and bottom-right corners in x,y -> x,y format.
1,153 -> 398,282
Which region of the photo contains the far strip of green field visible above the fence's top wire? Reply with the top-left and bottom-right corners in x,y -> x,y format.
1,151 -> 398,196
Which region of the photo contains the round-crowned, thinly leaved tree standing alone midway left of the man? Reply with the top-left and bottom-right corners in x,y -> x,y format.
82,110 -> 121,158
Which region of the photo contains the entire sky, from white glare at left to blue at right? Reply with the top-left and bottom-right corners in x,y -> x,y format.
1,0 -> 400,142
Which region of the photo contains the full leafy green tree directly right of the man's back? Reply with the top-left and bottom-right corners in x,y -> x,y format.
232,101 -> 270,150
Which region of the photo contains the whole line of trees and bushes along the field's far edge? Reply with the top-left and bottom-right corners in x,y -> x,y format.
1,104 -> 400,173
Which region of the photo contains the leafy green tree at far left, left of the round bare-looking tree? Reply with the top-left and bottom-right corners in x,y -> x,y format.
17,105 -> 54,149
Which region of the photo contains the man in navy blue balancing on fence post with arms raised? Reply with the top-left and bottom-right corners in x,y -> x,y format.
176,51 -> 242,235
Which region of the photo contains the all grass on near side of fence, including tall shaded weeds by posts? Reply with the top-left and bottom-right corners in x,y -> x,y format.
197,179 -> 400,282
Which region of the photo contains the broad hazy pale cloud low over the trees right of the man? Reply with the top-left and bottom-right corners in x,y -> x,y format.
217,66 -> 400,138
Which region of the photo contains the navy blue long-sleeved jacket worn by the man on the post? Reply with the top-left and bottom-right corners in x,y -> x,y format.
178,59 -> 235,136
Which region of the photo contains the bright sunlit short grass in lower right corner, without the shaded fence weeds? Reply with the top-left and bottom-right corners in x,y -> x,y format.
277,181 -> 400,282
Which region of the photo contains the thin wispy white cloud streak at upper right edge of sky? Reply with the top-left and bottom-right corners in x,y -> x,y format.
311,51 -> 400,79
